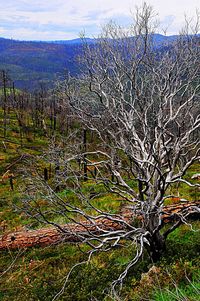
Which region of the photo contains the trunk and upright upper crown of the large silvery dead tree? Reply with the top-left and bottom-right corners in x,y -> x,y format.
64,5 -> 200,260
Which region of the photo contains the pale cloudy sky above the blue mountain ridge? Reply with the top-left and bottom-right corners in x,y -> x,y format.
0,0 -> 200,41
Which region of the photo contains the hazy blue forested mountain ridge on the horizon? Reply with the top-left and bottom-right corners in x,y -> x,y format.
0,34 -> 180,89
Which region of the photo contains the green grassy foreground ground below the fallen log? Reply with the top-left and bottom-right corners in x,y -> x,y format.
0,219 -> 200,301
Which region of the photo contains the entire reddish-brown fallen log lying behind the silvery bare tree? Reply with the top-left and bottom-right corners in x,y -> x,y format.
0,201 -> 200,251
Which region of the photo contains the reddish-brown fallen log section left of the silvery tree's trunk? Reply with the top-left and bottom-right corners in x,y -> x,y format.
0,218 -> 125,250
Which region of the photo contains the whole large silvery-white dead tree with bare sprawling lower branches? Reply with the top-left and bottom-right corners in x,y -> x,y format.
21,5 -> 200,296
